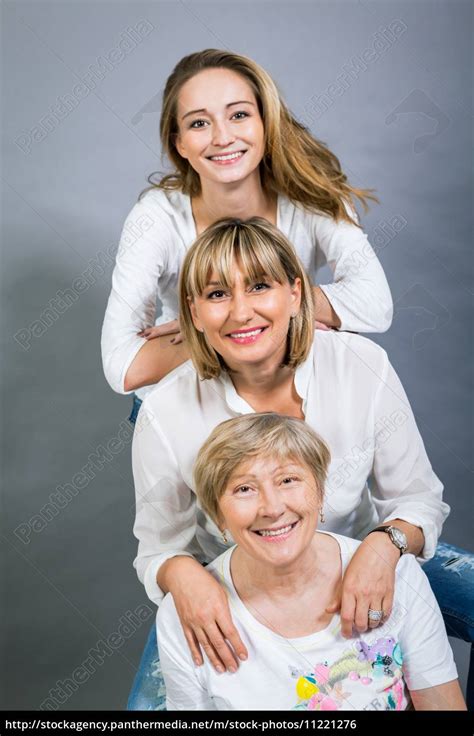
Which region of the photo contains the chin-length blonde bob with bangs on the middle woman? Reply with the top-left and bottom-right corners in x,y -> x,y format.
179,217 -> 314,379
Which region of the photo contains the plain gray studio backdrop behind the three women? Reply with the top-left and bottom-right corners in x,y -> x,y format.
1,0 -> 472,710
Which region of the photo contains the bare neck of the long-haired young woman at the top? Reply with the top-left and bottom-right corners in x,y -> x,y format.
192,169 -> 276,227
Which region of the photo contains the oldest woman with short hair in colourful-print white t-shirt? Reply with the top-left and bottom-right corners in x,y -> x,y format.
156,413 -> 466,711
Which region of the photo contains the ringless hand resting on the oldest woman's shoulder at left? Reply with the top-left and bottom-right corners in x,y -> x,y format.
165,557 -> 248,672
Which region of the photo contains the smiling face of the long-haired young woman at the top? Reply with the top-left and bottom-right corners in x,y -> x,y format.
176,68 -> 265,183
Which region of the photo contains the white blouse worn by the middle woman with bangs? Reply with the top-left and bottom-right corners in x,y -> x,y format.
132,330 -> 450,604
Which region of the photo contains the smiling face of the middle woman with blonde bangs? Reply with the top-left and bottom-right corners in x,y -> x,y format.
188,260 -> 301,371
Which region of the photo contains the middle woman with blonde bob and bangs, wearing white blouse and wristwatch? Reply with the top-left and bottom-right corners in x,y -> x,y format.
128,218 -> 472,712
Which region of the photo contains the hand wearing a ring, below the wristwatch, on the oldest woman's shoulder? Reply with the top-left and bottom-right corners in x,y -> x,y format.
326,533 -> 400,638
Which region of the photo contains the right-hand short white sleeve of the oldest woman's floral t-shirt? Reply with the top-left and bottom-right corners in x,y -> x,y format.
392,555 -> 458,690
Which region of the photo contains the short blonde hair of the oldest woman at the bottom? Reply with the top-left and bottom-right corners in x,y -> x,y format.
193,412 -> 331,526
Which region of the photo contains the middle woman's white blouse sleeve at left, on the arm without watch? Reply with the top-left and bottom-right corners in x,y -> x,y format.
132,399 -> 199,605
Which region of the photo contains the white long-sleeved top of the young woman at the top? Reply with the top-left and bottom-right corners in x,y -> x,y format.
101,189 -> 393,399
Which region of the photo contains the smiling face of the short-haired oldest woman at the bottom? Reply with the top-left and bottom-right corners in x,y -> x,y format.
219,456 -> 320,565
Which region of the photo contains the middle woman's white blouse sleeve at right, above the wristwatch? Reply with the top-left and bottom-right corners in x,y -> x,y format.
370,350 -> 450,562
